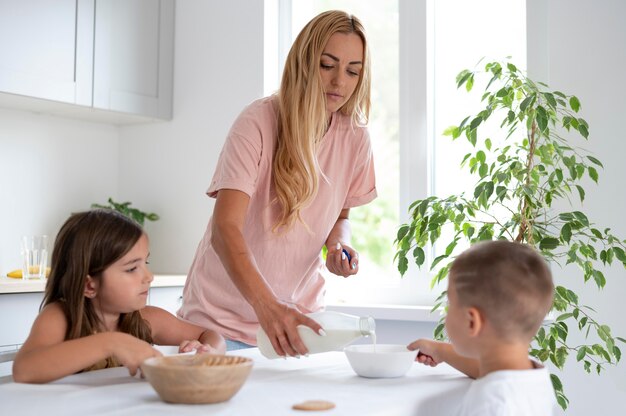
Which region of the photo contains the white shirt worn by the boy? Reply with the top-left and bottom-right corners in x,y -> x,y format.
458,360 -> 557,416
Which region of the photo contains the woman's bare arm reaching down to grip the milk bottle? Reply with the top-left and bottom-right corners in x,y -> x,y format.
211,189 -> 321,356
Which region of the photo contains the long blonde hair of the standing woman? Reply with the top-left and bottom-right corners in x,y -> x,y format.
272,10 -> 371,229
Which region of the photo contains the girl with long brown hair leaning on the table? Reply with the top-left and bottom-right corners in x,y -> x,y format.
13,210 -> 225,383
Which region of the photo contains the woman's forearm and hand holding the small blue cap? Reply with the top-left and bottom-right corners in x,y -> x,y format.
326,208 -> 359,277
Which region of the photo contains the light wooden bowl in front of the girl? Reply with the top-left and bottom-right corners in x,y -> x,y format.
141,354 -> 252,404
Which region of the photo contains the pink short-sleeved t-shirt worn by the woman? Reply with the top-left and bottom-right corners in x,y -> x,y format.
178,97 -> 376,345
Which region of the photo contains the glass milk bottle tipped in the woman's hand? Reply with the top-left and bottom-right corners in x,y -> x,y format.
256,311 -> 376,358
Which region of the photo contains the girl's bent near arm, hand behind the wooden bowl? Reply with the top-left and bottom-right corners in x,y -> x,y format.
13,303 -> 161,383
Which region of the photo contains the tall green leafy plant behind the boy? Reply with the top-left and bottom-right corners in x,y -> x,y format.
395,62 -> 626,409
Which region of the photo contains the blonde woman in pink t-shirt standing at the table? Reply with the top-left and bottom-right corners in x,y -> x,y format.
178,11 -> 376,356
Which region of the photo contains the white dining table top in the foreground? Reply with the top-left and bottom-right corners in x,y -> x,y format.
0,348 -> 471,416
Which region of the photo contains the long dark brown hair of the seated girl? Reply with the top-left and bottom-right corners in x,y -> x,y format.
41,209 -> 152,350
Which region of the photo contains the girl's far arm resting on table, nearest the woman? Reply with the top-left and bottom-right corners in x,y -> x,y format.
141,306 -> 226,354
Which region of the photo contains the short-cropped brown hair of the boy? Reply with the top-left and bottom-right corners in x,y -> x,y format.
450,240 -> 554,341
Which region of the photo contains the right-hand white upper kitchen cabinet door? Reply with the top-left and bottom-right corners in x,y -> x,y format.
93,0 -> 174,119
